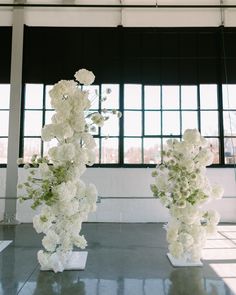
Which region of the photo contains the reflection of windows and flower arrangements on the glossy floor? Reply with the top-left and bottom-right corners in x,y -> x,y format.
26,267 -> 230,295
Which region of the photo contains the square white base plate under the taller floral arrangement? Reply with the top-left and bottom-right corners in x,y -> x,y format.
41,251 -> 88,271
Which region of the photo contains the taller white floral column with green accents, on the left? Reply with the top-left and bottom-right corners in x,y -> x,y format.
18,69 -> 120,272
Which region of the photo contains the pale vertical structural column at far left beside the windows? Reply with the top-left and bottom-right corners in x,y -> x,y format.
3,1 -> 24,224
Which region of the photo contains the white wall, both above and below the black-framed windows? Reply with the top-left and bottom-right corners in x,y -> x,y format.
0,0 -> 236,222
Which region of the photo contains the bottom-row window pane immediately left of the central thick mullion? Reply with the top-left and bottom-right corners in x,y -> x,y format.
101,138 -> 118,164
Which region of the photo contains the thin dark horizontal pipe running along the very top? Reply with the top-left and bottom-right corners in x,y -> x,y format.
0,3 -> 236,9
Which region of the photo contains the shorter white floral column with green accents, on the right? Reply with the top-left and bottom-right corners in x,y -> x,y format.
151,129 -> 223,262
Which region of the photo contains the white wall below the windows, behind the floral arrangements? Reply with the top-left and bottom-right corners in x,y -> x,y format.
12,168 -> 236,222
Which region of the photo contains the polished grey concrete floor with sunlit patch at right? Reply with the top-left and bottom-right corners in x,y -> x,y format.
0,223 -> 236,295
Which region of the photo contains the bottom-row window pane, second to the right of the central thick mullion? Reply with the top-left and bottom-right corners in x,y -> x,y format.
143,138 -> 161,164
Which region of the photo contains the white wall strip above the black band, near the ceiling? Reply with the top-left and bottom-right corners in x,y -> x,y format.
0,0 -> 236,27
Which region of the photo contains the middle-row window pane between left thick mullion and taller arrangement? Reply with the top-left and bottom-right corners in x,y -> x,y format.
24,111 -> 42,136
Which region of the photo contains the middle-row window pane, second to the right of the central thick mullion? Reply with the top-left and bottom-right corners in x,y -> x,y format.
144,111 -> 161,135
